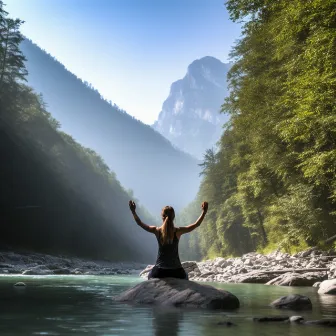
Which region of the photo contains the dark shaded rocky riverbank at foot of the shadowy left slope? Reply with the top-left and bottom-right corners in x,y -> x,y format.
0,251 -> 146,275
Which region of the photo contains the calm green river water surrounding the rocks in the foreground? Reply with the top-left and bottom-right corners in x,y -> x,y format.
0,276 -> 336,336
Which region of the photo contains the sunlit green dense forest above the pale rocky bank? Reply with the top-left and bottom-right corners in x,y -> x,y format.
179,0 -> 336,258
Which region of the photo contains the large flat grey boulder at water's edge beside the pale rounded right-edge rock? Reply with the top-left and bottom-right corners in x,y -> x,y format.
266,272 -> 327,286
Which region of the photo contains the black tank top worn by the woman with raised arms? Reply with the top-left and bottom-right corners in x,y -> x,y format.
155,231 -> 182,269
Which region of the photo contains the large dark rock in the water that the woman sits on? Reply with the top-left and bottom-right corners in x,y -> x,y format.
114,278 -> 239,310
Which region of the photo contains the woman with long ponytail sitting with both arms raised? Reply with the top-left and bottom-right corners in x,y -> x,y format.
129,201 -> 208,279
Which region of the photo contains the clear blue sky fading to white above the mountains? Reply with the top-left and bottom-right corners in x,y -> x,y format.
4,0 -> 240,124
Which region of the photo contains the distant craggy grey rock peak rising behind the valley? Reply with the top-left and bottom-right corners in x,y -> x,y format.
153,56 -> 231,158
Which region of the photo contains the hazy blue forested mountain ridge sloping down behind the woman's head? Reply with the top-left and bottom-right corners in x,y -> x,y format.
21,39 -> 200,214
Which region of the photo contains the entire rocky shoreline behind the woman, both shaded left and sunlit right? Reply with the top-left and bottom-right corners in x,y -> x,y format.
0,251 -> 336,287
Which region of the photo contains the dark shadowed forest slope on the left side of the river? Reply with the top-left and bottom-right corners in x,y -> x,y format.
0,1 -> 156,261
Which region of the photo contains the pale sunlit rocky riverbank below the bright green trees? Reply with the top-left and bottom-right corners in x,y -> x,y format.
140,251 -> 336,286
